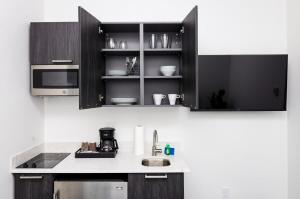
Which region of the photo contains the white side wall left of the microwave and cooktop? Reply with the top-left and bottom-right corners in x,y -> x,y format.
0,0 -> 44,199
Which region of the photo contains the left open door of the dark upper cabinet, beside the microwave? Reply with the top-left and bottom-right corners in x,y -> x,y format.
78,7 -> 105,109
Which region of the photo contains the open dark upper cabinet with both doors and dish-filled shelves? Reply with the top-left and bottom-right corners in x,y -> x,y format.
78,6 -> 198,109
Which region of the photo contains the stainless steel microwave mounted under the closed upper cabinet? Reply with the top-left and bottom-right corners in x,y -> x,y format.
31,65 -> 79,96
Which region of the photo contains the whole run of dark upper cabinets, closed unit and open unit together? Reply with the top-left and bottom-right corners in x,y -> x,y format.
30,6 -> 199,109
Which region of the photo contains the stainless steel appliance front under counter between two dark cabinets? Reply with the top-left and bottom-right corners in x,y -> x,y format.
53,181 -> 127,199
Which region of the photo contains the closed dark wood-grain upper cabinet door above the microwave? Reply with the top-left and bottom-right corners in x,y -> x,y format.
30,22 -> 79,65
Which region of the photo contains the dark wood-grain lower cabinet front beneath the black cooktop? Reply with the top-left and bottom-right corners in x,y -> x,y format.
14,174 -> 54,199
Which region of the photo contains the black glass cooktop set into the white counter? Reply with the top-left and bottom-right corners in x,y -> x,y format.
17,153 -> 70,168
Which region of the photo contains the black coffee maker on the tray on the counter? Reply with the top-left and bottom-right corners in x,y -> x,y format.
99,127 -> 119,153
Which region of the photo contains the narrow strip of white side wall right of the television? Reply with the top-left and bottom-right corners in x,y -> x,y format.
287,0 -> 300,199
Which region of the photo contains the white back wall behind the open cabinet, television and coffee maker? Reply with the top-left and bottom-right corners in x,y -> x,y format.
45,0 -> 287,199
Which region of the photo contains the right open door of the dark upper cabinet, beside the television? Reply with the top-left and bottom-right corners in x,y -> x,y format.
182,6 -> 198,109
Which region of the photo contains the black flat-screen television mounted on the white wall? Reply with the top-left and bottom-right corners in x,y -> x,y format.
198,55 -> 288,111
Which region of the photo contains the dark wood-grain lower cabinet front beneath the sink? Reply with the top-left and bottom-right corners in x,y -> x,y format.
128,173 -> 184,199
